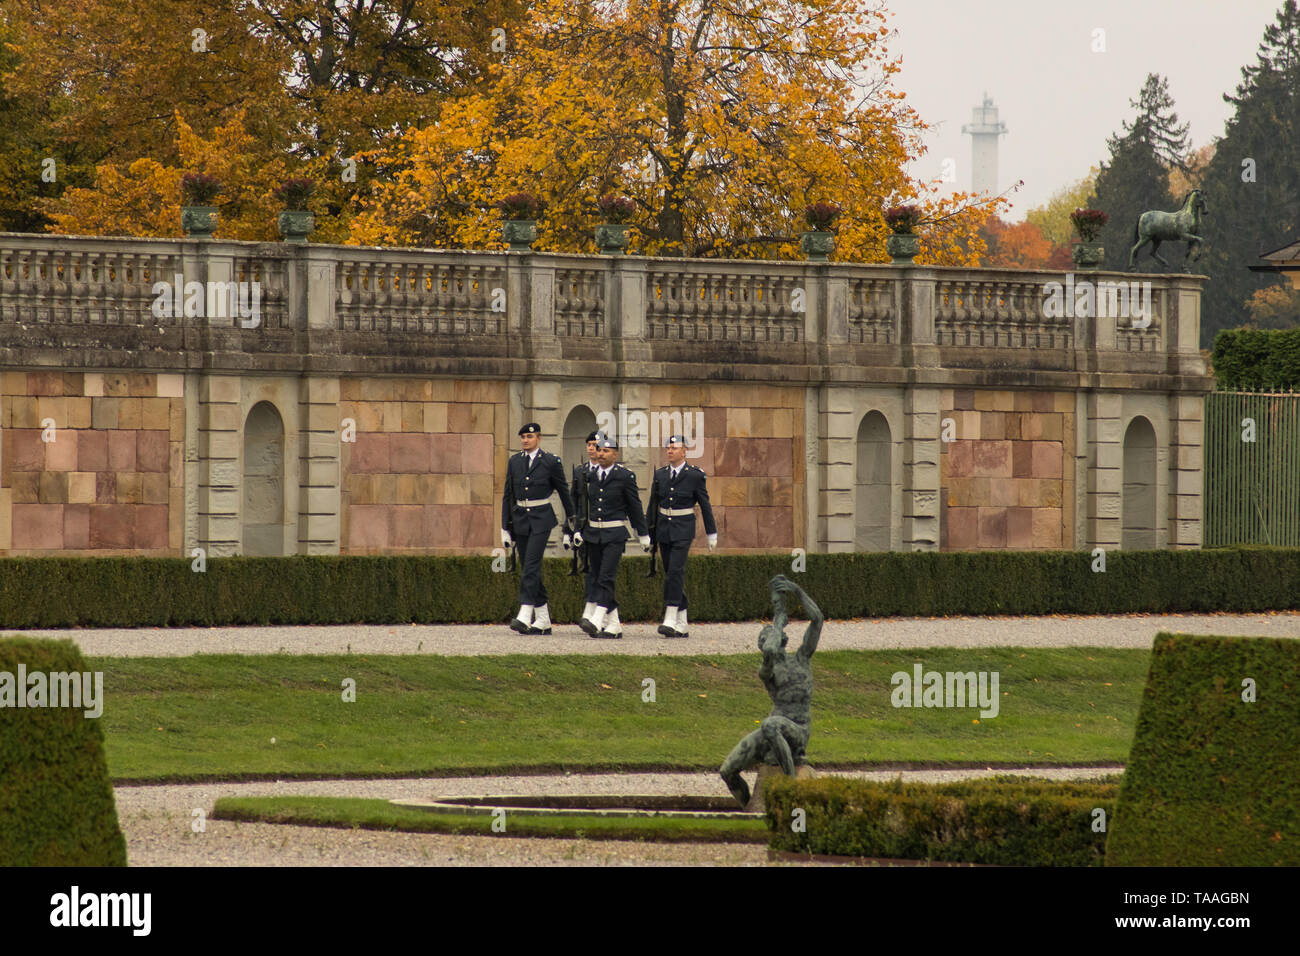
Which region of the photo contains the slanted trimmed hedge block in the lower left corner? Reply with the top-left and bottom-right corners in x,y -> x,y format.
0,637 -> 126,866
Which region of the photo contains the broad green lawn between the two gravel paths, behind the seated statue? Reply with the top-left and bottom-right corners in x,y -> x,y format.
87,648 -> 1149,780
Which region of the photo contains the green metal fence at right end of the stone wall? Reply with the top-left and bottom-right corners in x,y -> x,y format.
1203,392 -> 1300,548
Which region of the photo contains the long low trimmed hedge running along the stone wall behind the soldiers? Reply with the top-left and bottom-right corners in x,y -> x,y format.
0,546 -> 1300,628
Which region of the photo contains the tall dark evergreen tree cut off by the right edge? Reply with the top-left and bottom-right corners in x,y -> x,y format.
1196,0 -> 1300,346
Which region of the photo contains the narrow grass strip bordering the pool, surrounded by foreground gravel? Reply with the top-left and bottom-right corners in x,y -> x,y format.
212,797 -> 768,843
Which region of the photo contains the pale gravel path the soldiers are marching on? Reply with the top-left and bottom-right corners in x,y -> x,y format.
5,611 -> 1300,657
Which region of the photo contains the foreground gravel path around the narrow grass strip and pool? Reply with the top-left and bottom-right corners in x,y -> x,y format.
114,767 -> 1121,866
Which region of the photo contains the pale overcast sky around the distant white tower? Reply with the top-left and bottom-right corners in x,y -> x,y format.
887,0 -> 1282,221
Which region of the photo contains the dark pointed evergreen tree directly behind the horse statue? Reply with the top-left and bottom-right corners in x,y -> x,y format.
1088,73 -> 1188,272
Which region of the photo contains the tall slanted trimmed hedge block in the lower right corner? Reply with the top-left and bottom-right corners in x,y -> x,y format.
1106,633 -> 1300,866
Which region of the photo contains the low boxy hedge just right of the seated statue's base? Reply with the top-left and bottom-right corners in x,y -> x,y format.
763,777 -> 1118,866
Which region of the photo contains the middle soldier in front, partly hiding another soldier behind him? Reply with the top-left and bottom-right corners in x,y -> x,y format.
573,437 -> 650,637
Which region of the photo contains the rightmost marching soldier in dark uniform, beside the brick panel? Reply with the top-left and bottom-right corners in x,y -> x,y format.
646,434 -> 718,637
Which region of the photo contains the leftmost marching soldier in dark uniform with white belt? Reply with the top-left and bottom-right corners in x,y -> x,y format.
501,421 -> 573,633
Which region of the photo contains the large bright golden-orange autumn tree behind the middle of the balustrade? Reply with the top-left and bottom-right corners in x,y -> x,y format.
352,0 -> 987,263
